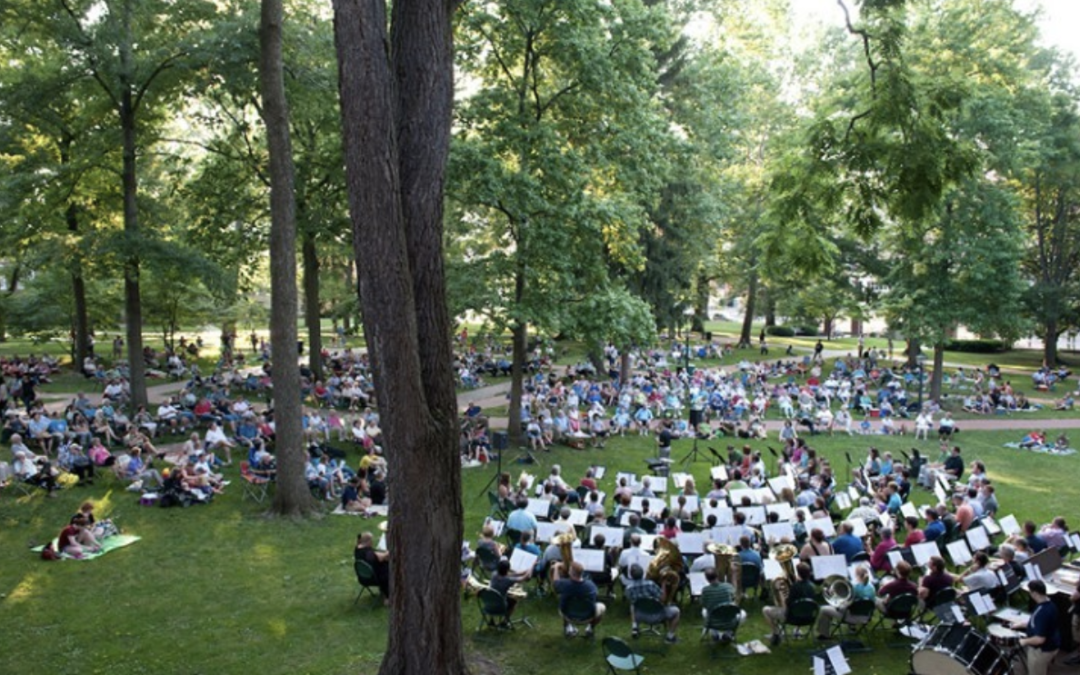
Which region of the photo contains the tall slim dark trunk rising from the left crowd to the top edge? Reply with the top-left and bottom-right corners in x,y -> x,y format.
120,9 -> 147,409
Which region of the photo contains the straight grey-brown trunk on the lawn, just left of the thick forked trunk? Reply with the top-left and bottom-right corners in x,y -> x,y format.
259,0 -> 315,509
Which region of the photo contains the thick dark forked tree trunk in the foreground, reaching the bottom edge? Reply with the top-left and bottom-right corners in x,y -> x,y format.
334,0 -> 467,675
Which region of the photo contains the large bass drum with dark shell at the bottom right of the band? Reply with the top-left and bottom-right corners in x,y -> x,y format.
912,623 -> 1009,675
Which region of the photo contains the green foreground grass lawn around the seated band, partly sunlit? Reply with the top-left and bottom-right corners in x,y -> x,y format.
0,425 -> 1080,675
